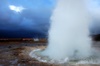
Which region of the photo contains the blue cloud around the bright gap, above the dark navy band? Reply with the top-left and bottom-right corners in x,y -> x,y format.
0,0 -> 53,33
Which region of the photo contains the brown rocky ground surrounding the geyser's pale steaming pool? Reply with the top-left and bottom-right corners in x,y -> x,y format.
0,42 -> 100,66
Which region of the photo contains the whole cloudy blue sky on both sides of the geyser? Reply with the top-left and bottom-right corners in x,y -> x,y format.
0,0 -> 100,38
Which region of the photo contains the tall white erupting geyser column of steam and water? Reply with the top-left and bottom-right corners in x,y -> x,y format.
41,0 -> 91,60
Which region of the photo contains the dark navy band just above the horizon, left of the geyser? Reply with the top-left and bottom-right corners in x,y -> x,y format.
0,30 -> 46,38
